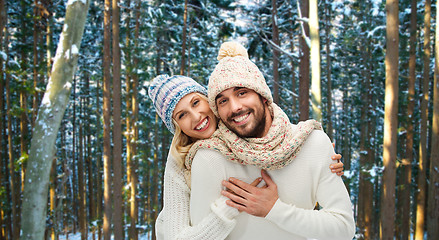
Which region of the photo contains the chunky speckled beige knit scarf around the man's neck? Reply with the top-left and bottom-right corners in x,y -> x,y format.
185,103 -> 322,170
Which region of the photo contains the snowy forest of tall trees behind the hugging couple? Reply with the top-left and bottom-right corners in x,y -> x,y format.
0,0 -> 439,240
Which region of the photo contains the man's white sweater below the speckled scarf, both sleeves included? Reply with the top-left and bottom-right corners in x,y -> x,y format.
190,130 -> 355,240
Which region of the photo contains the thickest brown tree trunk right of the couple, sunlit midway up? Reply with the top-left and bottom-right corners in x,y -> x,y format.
380,0 -> 399,240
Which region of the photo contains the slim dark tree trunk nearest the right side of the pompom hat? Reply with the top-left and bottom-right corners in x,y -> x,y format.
271,0 -> 280,104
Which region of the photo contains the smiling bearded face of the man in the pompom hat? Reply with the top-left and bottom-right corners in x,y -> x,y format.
215,87 -> 267,138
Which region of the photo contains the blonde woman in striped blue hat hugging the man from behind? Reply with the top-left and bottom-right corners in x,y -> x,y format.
149,75 -> 343,239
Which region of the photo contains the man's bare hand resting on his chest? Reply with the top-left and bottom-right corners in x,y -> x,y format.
221,170 -> 279,217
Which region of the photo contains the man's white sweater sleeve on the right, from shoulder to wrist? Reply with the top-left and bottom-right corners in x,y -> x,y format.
266,131 -> 355,239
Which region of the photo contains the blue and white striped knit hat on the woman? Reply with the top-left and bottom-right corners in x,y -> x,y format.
148,74 -> 207,133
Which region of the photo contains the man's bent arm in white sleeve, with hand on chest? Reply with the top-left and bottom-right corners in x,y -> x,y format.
223,131 -> 355,239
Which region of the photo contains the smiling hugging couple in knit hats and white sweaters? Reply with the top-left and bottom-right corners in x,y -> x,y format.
149,42 -> 355,240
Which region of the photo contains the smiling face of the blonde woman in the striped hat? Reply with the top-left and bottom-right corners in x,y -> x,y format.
172,93 -> 217,140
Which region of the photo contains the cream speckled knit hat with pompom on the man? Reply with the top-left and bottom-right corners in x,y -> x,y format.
207,42 -> 273,117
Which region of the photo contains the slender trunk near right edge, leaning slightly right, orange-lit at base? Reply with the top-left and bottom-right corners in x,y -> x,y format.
415,0 -> 431,239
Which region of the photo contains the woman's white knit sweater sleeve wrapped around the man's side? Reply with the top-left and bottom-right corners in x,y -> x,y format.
156,151 -> 238,240
